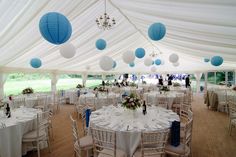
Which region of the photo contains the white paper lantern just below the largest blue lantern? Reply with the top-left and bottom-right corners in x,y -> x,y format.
60,43 -> 76,59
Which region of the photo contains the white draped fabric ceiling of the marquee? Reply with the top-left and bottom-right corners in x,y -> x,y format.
0,0 -> 236,74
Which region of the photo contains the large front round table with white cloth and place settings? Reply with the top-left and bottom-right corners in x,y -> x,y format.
90,105 -> 180,157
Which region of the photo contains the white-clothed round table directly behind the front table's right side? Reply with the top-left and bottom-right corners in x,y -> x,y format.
144,91 -> 184,109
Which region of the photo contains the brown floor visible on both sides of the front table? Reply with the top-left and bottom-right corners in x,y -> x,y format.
25,95 -> 236,157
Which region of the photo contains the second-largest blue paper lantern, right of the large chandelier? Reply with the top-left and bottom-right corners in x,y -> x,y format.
148,23 -> 166,41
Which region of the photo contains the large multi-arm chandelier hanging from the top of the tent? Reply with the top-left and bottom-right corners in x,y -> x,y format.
96,0 -> 116,30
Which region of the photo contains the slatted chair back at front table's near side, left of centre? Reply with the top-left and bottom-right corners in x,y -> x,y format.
91,128 -> 116,157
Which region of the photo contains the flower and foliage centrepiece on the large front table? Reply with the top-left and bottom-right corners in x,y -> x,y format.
121,93 -> 142,110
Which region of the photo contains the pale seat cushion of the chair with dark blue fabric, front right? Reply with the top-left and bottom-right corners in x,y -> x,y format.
165,143 -> 190,155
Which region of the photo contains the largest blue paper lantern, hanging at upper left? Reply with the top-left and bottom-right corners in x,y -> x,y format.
39,12 -> 72,45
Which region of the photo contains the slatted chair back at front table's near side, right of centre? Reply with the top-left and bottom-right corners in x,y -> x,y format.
141,129 -> 169,157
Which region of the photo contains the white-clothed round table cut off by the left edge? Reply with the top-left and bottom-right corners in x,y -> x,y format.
0,107 -> 41,157
